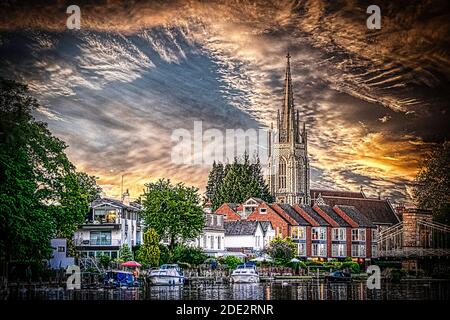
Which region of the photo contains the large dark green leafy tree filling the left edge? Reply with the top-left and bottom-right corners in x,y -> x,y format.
0,79 -> 100,274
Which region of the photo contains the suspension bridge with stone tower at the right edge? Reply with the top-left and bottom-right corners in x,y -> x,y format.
378,214 -> 450,259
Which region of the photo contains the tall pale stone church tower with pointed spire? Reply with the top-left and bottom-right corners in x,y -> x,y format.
268,53 -> 310,204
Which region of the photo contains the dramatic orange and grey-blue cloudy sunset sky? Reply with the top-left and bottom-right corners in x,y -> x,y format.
0,0 -> 450,201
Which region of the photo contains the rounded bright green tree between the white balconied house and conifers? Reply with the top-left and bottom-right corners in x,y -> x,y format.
142,179 -> 205,252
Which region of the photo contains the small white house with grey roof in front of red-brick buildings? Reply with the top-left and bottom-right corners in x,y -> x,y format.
224,220 -> 268,254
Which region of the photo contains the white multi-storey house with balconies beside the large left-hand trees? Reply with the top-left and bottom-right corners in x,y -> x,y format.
74,198 -> 142,259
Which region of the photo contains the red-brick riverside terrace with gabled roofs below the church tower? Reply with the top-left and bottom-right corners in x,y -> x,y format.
216,197 -> 390,262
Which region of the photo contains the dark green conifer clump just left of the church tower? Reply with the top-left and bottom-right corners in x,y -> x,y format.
206,153 -> 273,210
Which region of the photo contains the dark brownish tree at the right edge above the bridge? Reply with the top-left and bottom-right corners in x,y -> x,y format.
414,141 -> 450,225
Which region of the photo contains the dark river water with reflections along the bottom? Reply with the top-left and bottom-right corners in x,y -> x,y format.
8,280 -> 450,300
